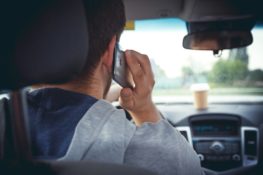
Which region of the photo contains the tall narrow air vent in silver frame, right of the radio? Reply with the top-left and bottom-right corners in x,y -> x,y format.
241,127 -> 259,166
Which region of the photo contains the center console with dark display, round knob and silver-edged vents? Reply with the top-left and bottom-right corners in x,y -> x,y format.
177,114 -> 258,171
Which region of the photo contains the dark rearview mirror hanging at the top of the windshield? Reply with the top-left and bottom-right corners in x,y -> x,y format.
183,18 -> 255,51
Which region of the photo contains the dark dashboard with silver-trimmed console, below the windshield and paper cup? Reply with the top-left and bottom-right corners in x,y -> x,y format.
158,103 -> 263,174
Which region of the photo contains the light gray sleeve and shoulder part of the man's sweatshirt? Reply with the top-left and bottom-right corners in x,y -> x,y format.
60,100 -> 202,175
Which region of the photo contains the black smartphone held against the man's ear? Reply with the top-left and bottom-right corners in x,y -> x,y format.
112,44 -> 133,88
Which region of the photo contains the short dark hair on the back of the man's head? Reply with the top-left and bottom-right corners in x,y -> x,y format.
83,0 -> 126,74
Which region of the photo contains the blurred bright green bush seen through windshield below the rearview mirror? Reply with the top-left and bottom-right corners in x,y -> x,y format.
208,60 -> 248,85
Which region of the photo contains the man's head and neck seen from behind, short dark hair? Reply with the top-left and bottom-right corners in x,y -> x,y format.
31,0 -> 126,98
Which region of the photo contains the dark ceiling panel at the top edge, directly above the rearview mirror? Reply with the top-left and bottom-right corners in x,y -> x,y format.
179,0 -> 255,22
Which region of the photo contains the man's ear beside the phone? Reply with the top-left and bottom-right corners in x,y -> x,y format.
102,35 -> 116,68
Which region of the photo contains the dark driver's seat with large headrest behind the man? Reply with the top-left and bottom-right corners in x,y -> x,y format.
0,0 -> 157,175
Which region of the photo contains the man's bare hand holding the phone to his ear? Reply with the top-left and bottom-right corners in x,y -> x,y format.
120,51 -> 161,126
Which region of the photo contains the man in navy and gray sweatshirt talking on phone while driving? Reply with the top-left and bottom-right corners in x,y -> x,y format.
28,0 -> 202,175
